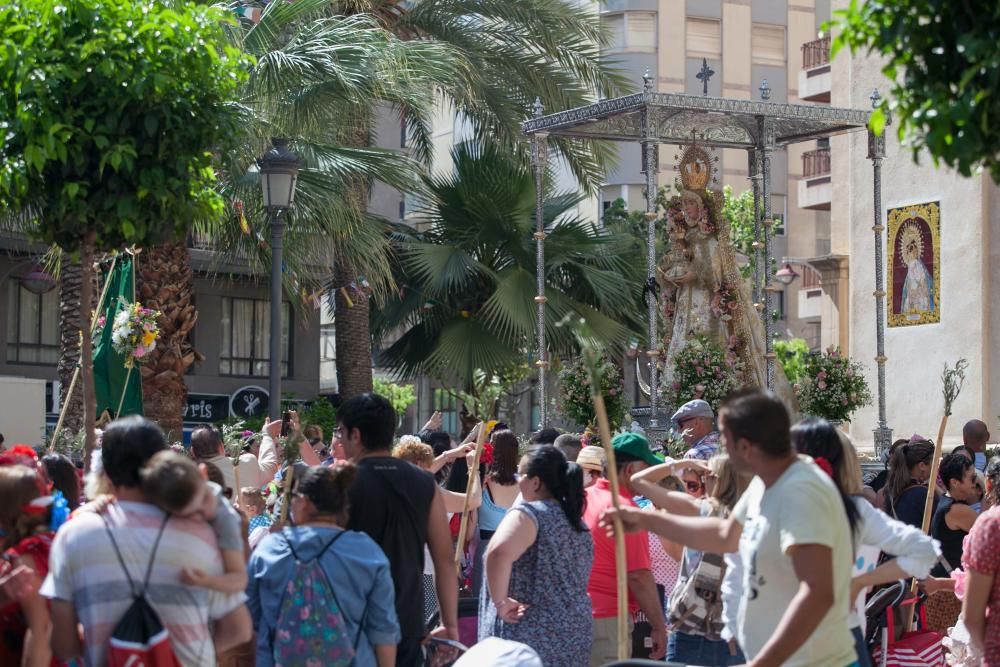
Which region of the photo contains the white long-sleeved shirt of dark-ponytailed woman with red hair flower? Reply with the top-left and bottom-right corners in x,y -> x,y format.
850,496 -> 941,628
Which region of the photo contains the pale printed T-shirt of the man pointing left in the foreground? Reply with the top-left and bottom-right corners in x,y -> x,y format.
732,461 -> 857,667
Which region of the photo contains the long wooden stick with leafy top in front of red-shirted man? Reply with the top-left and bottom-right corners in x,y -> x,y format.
560,319 -> 631,660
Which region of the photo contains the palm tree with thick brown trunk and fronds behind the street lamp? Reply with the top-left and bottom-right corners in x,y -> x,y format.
138,0 -> 457,434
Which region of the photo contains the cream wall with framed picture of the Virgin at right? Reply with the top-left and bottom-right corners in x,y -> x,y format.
829,0 -> 1000,447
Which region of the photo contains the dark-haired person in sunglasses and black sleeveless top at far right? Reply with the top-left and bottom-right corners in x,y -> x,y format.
931,453 -> 979,577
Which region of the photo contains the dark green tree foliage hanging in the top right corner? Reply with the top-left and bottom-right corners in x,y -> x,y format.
832,0 -> 1000,182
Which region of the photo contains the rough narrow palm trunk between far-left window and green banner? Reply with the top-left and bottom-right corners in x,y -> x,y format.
57,254 -> 97,433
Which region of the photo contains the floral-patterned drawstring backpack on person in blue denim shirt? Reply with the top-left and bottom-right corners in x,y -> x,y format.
272,528 -> 363,667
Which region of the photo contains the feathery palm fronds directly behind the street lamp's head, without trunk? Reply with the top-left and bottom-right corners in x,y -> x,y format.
215,0 -> 461,296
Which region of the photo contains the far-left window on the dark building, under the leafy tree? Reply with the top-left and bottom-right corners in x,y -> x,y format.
7,279 -> 59,364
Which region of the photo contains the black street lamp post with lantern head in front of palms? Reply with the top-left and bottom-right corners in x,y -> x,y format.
257,139 -> 299,421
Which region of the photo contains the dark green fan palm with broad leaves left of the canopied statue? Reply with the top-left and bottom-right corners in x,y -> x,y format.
372,142 -> 644,391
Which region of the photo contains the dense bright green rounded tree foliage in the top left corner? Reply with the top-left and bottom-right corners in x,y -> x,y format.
0,0 -> 247,250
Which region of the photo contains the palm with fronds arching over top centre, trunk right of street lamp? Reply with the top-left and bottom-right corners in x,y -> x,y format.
334,0 -> 628,396
